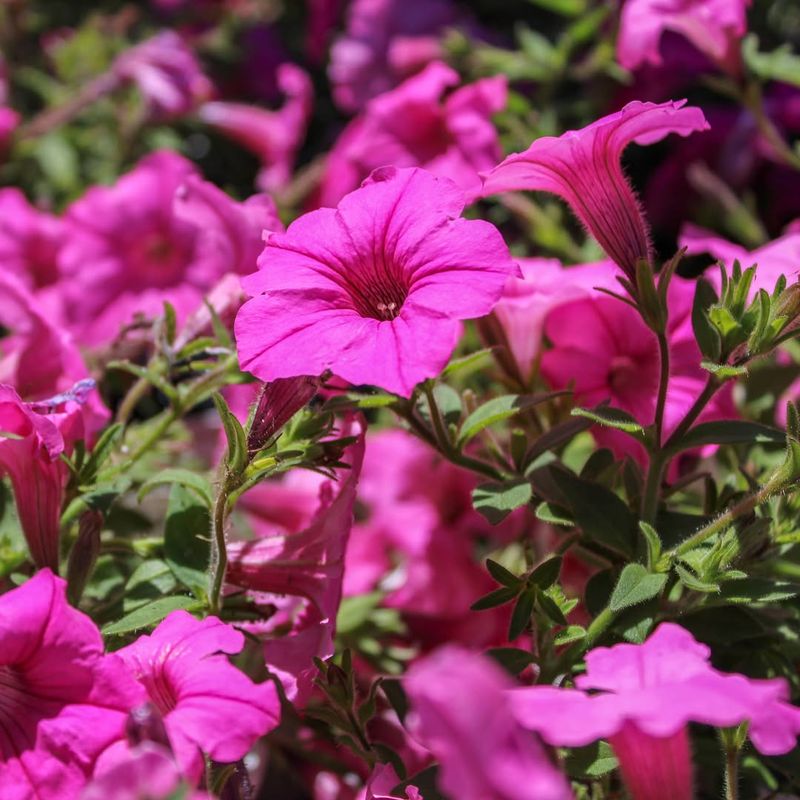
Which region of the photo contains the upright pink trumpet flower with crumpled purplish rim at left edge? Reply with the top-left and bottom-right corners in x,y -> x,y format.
0,381 -> 94,572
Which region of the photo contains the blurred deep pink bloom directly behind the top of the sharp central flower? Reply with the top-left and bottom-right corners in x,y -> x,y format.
319,61 -> 507,206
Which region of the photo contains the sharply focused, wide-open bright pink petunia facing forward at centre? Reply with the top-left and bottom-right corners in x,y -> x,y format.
235,168 -> 518,396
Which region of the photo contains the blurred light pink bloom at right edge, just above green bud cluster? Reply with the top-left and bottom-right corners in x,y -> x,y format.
680,225 -> 800,295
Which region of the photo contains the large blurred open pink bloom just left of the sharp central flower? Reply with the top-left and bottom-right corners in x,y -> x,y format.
59,151 -> 274,344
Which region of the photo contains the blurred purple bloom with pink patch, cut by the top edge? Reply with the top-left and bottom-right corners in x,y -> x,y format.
328,0 -> 463,111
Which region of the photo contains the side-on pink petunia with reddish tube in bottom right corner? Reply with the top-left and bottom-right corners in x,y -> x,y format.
510,622 -> 800,800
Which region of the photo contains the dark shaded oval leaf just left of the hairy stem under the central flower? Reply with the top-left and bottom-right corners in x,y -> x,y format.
164,483 -> 211,600
